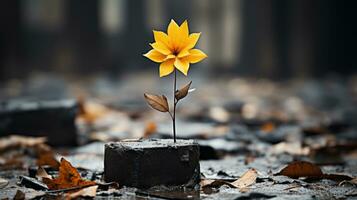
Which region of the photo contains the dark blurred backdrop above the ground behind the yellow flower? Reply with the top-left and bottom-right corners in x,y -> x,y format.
0,0 -> 357,82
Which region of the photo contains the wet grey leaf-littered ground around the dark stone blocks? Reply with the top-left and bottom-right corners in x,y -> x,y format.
0,74 -> 357,199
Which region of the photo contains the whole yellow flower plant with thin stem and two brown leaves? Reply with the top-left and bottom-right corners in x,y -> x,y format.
144,20 -> 207,143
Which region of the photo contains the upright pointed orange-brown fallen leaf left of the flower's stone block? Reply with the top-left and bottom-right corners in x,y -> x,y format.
43,158 -> 96,190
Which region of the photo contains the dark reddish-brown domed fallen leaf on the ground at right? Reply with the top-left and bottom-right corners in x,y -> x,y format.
277,161 -> 323,178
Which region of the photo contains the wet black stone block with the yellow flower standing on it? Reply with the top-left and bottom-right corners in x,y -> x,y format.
104,139 -> 200,188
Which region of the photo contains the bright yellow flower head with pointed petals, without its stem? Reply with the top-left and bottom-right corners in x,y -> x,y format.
144,20 -> 207,77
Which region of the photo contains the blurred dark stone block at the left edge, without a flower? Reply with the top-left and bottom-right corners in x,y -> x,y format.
0,100 -> 78,146
